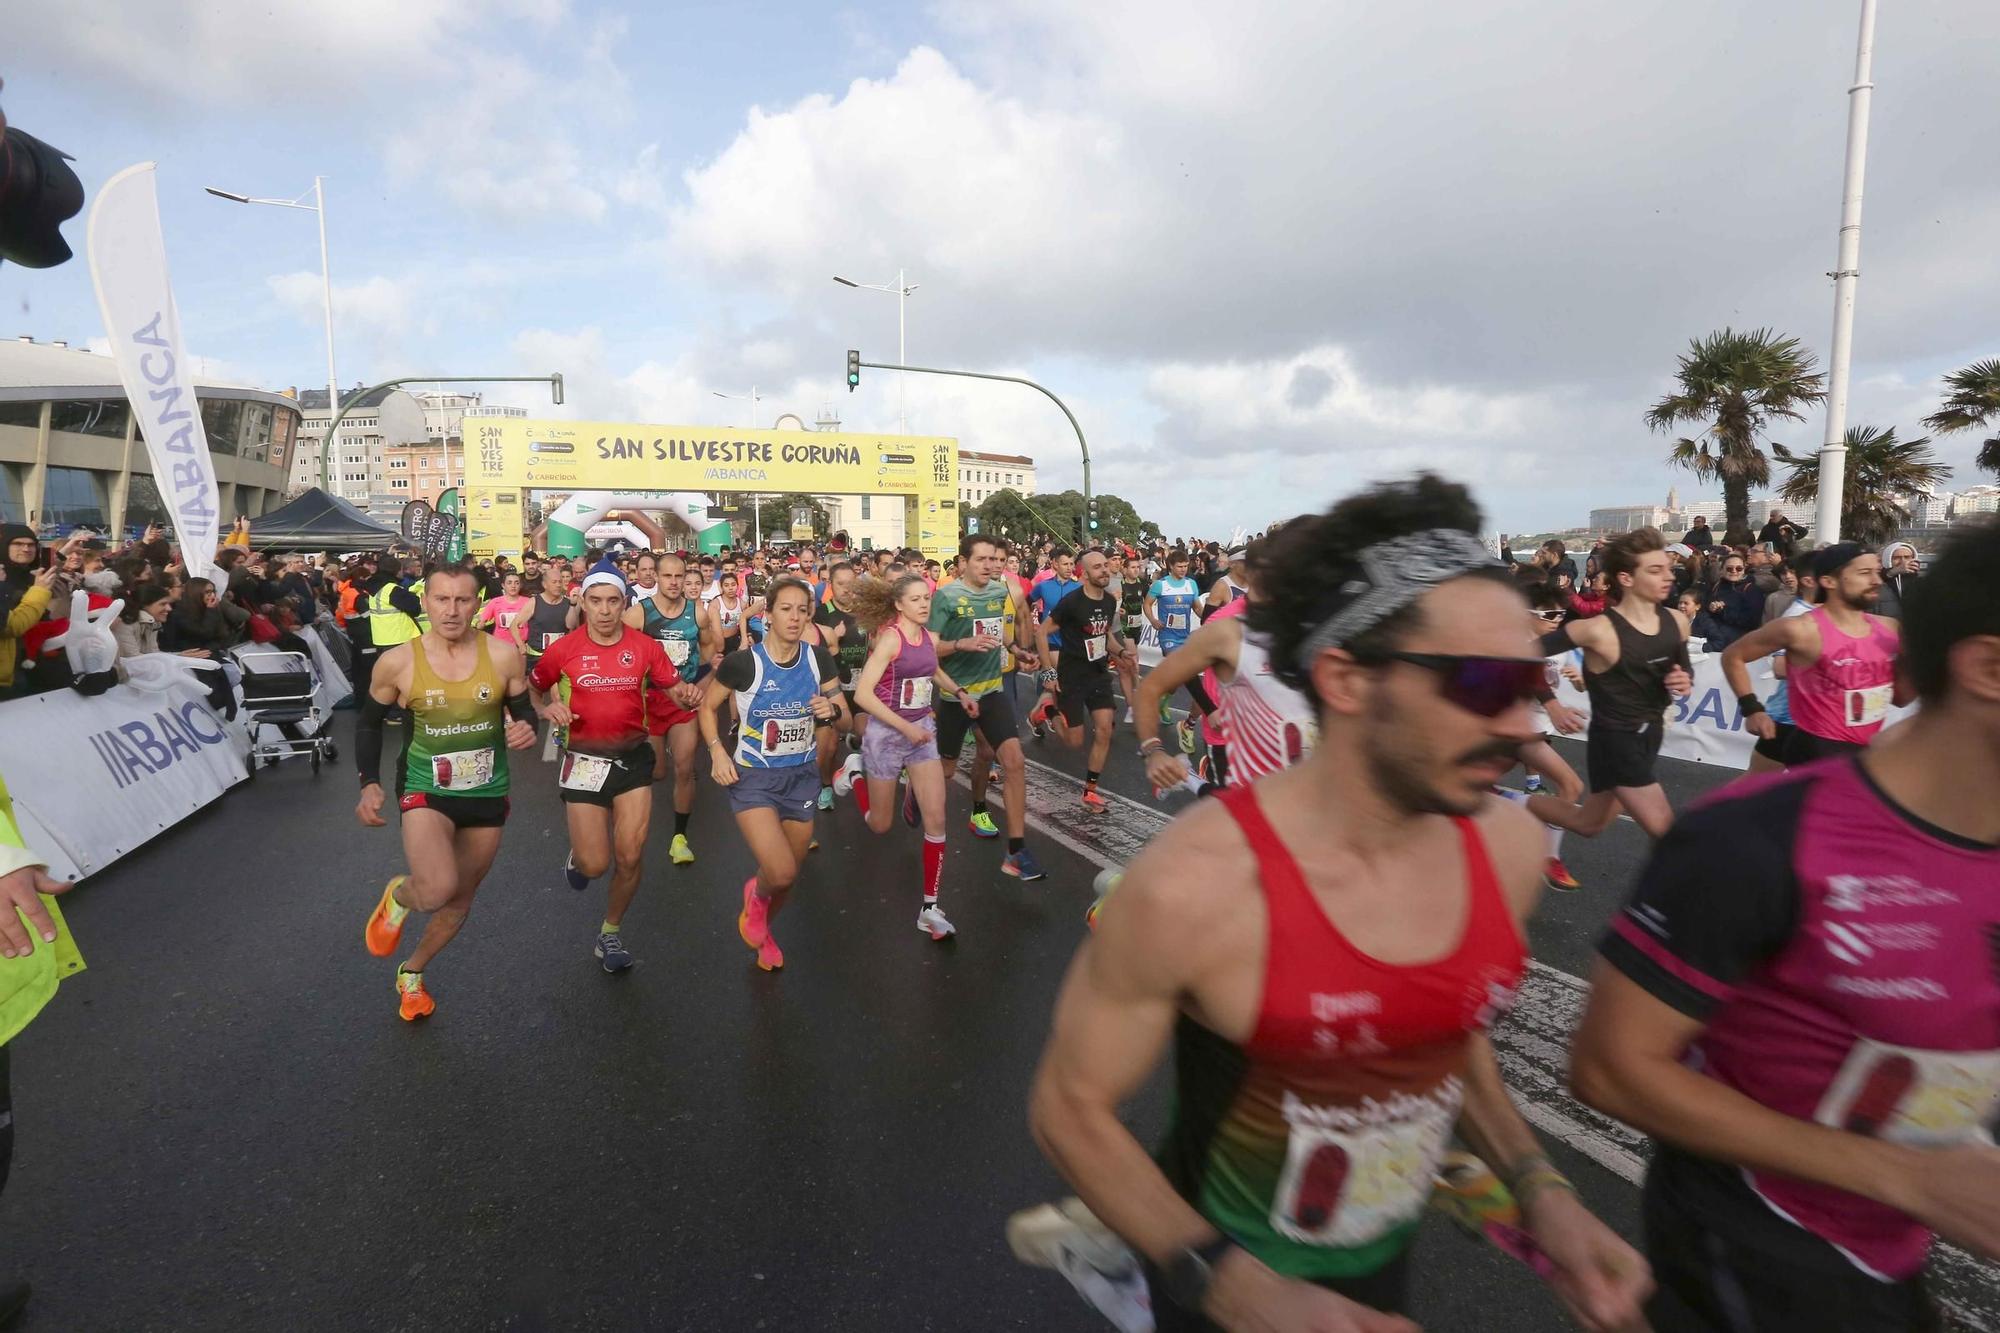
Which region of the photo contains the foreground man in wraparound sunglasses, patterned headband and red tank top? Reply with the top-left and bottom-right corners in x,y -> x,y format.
1030,476 -> 1650,1333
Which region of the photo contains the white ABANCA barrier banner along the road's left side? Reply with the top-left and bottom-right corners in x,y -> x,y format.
0,675 -> 250,879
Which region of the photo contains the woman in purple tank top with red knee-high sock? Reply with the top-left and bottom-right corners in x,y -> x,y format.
854,574 -> 980,939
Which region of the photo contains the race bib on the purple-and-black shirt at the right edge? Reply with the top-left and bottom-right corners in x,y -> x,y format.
1812,1037 -> 2000,1147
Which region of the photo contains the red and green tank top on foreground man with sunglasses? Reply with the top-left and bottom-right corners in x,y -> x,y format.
1158,787 -> 1528,1279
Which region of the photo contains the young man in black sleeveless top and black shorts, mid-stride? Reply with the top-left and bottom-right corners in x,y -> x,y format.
1528,528 -> 1694,839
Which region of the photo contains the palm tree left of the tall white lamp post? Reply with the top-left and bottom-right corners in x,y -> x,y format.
1646,328 -> 1826,544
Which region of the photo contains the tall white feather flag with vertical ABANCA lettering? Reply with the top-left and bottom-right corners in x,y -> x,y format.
90,162 -> 222,578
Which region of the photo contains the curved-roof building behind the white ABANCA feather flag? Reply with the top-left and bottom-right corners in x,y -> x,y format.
0,338 -> 300,536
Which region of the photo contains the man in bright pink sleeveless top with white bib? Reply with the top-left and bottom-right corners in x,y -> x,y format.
1722,542 -> 1902,765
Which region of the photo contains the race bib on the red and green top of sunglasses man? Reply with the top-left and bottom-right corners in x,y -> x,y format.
1270,1083 -> 1458,1249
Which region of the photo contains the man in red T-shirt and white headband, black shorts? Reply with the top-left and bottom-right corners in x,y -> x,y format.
528,570 -> 686,973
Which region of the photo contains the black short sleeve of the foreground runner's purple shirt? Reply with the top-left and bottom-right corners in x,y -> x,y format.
1598,781 -> 1812,1019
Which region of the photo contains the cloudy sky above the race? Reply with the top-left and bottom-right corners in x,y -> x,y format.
0,0 -> 2000,534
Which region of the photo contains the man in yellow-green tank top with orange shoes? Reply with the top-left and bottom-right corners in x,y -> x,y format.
354,564 -> 536,1019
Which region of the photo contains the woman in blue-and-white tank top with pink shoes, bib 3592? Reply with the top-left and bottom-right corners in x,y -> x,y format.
702,578 -> 846,973
